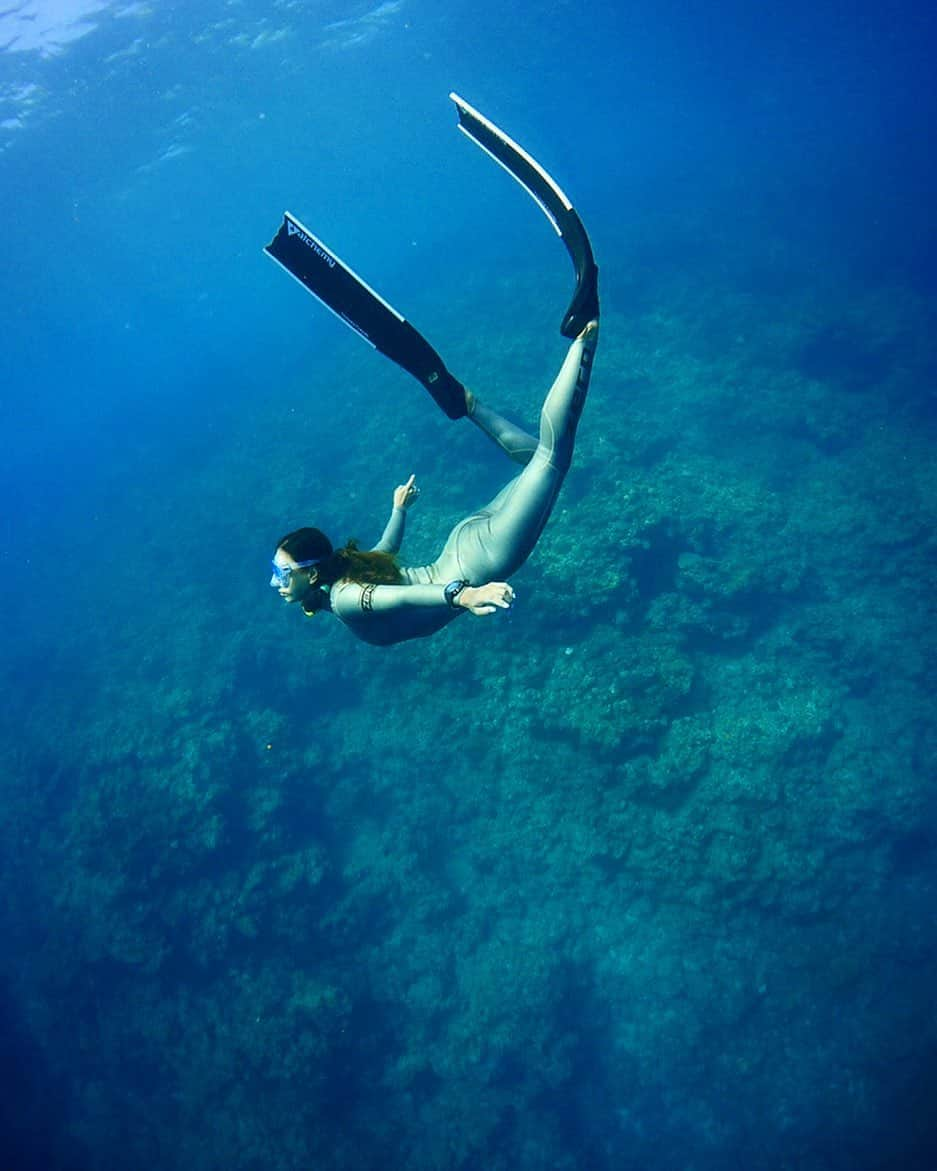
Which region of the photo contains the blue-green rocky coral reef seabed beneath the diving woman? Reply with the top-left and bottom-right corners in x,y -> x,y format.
0,237 -> 937,1171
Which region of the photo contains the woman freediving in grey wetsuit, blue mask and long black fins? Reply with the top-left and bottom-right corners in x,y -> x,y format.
266,95 -> 599,646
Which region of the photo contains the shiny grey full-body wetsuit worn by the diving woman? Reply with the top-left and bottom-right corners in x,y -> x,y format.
330,328 -> 599,646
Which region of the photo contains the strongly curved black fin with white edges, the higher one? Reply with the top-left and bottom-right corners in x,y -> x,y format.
449,94 -> 599,337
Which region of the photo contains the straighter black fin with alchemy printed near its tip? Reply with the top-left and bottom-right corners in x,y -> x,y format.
264,212 -> 465,419
